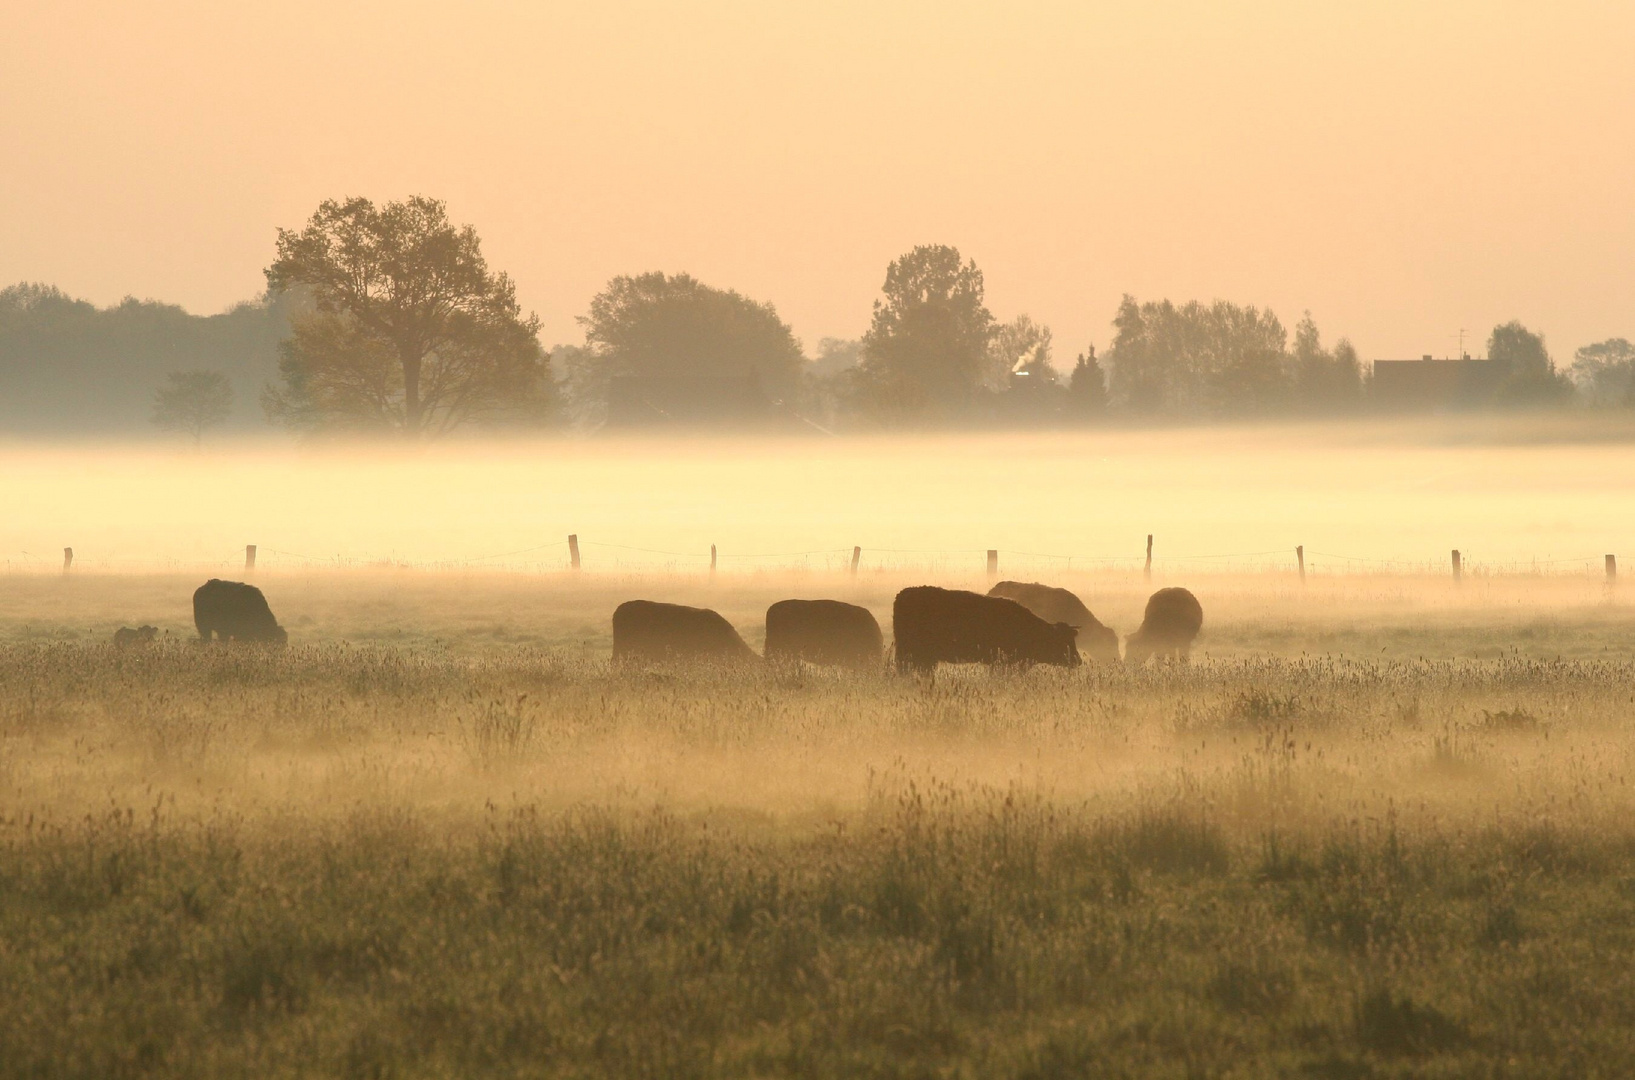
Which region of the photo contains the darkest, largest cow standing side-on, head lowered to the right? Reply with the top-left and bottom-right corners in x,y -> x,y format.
891,585 -> 1079,672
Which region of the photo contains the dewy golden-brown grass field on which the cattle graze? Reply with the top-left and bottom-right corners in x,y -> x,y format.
0,570 -> 1635,1078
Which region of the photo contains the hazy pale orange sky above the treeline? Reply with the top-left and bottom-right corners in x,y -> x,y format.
0,0 -> 1635,364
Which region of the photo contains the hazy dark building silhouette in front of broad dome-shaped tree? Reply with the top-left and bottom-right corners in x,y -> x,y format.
603,374 -> 822,431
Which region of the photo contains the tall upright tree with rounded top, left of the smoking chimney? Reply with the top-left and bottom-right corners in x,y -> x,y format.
857,245 -> 994,422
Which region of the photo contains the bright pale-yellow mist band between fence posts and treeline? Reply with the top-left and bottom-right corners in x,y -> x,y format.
0,418 -> 1635,573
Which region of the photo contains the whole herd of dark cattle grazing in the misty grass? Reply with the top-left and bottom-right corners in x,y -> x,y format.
114,578 -> 1203,672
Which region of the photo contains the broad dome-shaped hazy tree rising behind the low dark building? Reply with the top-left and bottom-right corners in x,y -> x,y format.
574,273 -> 804,415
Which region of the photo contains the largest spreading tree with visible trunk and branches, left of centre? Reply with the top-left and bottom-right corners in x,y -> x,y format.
263,196 -> 551,438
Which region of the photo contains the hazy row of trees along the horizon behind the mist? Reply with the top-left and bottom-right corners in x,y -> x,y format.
0,198 -> 1635,441
